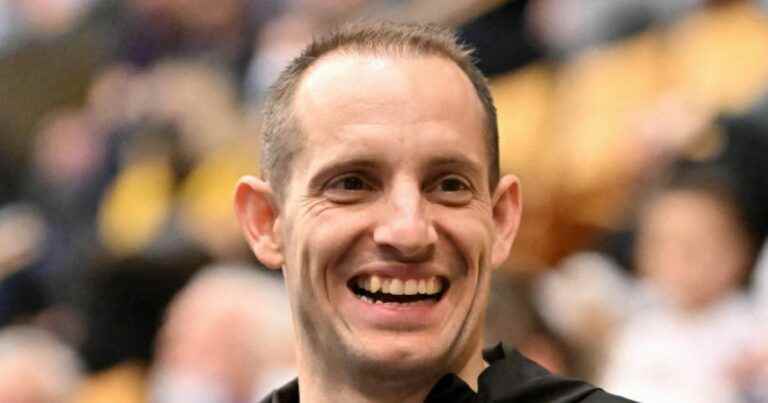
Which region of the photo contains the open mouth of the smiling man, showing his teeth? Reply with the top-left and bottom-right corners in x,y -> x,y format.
347,274 -> 448,304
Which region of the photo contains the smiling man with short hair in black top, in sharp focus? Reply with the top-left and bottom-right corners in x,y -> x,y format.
235,23 -> 636,403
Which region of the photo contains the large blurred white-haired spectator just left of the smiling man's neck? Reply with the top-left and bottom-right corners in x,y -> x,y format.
150,266 -> 295,403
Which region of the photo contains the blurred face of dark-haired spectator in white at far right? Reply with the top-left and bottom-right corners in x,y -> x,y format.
638,190 -> 749,312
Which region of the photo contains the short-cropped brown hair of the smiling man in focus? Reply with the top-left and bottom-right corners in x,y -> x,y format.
261,22 -> 500,198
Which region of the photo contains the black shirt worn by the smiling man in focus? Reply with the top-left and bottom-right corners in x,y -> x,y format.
261,344 -> 632,403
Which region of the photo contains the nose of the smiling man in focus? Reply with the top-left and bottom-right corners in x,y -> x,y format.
373,184 -> 437,261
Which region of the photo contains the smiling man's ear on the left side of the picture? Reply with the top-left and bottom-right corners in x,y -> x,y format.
235,176 -> 284,269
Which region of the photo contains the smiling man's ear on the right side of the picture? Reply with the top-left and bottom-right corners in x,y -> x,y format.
491,175 -> 523,268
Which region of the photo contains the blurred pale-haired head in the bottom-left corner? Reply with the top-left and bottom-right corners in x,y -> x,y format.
0,327 -> 82,403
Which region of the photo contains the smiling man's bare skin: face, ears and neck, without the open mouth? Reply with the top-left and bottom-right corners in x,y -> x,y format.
235,52 -> 521,402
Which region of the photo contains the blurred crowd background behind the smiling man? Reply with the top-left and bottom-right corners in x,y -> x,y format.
0,0 -> 768,403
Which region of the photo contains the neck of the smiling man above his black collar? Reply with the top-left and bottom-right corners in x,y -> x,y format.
298,343 -> 486,403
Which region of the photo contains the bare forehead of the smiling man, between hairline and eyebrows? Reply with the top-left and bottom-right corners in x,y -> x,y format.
293,52 -> 487,176
